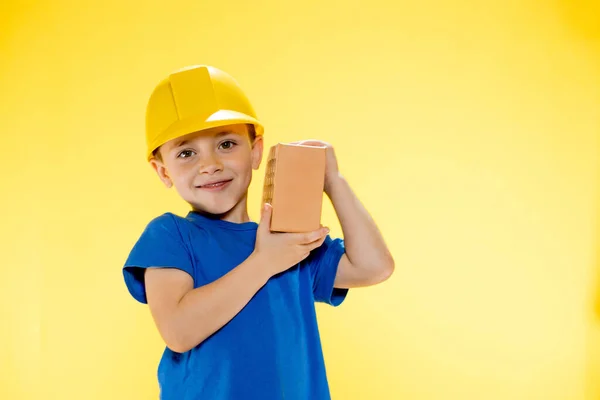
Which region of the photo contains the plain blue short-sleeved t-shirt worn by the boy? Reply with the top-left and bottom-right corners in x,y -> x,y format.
123,211 -> 348,400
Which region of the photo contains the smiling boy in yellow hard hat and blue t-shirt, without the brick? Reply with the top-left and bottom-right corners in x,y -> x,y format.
123,66 -> 394,400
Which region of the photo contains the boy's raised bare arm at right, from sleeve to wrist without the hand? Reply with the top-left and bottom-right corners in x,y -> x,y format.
325,171 -> 394,288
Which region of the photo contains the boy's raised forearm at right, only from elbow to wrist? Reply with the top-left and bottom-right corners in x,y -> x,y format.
325,175 -> 394,275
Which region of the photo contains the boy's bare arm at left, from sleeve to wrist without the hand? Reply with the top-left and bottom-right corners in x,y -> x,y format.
145,254 -> 270,353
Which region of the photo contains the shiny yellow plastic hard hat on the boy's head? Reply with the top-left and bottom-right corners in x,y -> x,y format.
146,65 -> 264,161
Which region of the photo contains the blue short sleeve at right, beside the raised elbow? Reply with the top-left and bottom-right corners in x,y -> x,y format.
307,235 -> 348,306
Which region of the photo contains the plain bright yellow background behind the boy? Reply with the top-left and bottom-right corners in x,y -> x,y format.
0,0 -> 600,400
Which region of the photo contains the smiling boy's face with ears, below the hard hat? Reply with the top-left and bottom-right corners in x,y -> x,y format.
151,124 -> 263,214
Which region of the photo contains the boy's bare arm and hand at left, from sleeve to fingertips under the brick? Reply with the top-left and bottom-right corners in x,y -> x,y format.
145,207 -> 327,353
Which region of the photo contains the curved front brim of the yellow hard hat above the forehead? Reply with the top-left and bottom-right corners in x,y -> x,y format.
146,110 -> 264,161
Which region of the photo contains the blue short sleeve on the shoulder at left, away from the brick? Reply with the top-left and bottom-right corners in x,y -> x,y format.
123,213 -> 194,304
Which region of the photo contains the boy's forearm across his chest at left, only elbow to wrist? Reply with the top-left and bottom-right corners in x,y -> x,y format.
171,254 -> 269,352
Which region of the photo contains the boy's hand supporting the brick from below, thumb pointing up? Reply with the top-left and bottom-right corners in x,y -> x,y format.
254,204 -> 329,278
